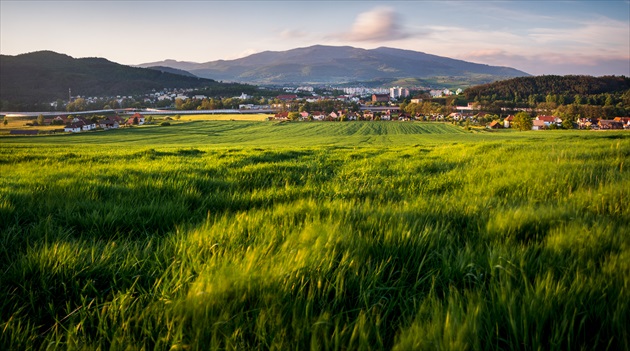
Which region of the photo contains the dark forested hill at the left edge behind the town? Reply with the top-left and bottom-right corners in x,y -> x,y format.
0,51 -> 230,103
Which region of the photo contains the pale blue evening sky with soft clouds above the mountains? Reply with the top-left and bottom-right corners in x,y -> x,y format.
0,0 -> 630,76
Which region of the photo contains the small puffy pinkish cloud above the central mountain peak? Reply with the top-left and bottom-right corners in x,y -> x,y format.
341,7 -> 412,42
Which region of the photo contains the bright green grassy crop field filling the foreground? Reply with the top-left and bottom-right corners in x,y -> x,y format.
0,121 -> 630,350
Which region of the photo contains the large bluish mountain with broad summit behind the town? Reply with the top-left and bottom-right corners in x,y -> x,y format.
139,45 -> 529,84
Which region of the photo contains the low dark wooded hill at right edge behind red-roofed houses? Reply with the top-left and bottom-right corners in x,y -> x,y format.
464,75 -> 630,101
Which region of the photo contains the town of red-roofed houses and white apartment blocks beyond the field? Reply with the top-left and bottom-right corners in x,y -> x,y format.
5,87 -> 630,135
